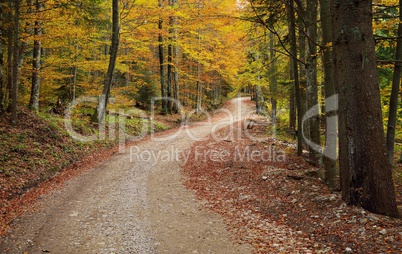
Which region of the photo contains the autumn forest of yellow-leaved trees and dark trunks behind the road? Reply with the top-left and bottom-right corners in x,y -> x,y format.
0,0 -> 402,244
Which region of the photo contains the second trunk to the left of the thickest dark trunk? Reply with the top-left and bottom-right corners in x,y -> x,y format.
306,0 -> 321,161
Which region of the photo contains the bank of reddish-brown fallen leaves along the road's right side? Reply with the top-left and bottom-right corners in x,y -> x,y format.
183,124 -> 402,253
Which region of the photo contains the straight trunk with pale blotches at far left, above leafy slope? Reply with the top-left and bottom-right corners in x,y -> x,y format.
29,0 -> 42,111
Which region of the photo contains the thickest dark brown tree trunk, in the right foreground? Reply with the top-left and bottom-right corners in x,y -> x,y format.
331,0 -> 398,217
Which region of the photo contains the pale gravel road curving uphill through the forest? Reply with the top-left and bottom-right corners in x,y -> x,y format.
0,98 -> 251,253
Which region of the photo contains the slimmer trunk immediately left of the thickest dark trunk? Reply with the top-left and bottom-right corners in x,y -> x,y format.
320,0 -> 339,189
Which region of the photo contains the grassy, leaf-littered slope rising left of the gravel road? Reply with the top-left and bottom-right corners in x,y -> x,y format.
0,109 -> 169,210
